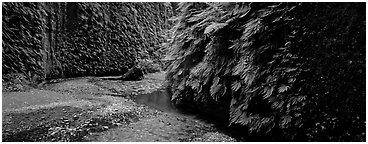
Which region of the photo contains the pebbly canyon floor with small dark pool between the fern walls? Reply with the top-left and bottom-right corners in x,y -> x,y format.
2,73 -> 237,142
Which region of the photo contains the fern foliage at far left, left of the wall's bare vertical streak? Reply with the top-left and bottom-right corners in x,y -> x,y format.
2,2 -> 44,80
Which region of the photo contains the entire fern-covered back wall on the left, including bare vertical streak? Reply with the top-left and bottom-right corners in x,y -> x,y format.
2,3 -> 172,80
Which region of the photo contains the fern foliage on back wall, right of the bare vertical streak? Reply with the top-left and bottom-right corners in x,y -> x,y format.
59,3 -> 171,75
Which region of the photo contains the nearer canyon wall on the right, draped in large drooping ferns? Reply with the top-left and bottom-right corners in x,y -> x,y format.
167,3 -> 366,141
